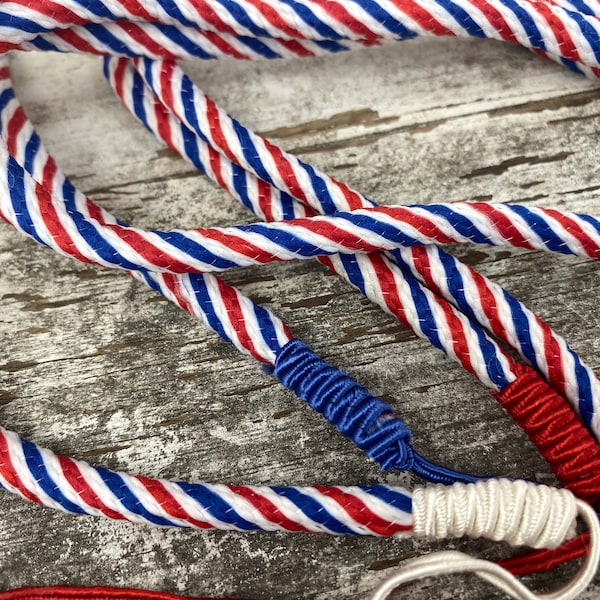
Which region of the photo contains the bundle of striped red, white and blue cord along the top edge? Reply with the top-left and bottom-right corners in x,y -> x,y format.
0,0 -> 600,76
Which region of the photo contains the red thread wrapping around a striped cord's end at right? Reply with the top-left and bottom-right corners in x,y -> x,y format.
494,365 -> 600,504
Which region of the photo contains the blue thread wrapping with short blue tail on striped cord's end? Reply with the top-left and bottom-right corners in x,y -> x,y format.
273,339 -> 480,483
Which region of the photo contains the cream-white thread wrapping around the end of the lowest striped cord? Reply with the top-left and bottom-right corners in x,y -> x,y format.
413,479 -> 577,549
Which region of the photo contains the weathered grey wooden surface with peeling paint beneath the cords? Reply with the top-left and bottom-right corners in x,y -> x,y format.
0,40 -> 600,600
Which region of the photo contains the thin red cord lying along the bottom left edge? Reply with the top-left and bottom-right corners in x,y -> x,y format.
0,585 -> 251,600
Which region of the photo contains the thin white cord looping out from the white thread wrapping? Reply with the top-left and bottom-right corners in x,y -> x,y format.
369,500 -> 600,600
